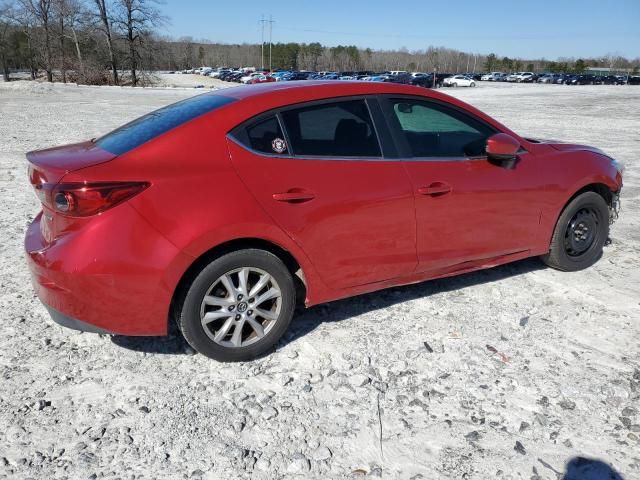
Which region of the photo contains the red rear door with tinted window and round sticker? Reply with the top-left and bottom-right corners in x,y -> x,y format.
228,98 -> 417,289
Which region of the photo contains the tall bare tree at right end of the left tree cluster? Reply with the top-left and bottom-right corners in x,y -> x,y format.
117,0 -> 165,87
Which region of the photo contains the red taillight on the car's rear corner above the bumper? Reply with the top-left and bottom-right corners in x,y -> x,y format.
34,182 -> 149,217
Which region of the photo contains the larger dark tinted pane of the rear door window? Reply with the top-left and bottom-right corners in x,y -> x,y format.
281,100 -> 381,157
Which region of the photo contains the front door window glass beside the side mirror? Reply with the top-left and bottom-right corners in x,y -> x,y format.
389,98 -> 494,158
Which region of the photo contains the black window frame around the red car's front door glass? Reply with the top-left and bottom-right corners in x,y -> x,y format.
378,93 -> 501,162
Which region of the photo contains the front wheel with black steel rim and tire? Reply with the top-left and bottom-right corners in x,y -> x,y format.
540,192 -> 609,272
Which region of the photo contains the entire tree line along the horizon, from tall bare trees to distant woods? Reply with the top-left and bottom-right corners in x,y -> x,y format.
0,0 -> 640,86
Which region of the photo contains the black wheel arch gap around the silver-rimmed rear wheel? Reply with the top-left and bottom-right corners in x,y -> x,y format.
168,237 -> 308,322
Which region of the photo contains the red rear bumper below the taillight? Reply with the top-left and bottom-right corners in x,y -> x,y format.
25,204 -> 190,335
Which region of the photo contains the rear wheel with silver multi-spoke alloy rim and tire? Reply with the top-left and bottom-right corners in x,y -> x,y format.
178,249 -> 296,362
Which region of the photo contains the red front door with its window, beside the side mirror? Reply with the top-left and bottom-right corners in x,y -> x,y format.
382,97 -> 544,271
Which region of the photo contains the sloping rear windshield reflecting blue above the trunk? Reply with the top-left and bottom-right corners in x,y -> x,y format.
96,95 -> 235,155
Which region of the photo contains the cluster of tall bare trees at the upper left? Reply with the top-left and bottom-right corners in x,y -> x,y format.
0,0 -> 167,86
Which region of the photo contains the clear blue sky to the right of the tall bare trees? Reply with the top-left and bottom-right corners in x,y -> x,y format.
162,0 -> 640,59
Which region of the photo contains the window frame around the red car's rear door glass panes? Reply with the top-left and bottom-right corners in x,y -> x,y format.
227,94 -> 390,162
